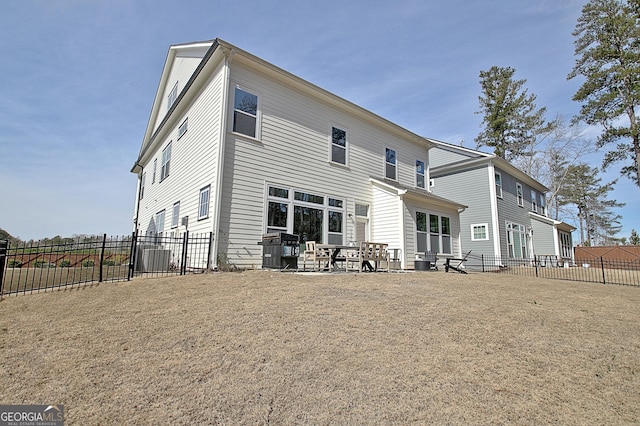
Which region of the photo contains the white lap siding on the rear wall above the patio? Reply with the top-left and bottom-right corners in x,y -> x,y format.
219,63 -> 427,267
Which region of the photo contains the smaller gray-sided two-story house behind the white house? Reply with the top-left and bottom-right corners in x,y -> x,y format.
429,139 -> 575,263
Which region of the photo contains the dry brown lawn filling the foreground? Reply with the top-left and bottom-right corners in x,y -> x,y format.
0,271 -> 640,425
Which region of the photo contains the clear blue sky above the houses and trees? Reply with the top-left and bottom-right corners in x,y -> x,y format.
0,0 -> 640,240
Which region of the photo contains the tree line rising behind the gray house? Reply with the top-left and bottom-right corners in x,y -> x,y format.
475,0 -> 640,245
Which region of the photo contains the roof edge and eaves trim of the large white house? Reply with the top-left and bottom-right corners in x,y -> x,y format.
131,38 -> 433,173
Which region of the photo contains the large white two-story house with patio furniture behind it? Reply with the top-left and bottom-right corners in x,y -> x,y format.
131,39 -> 466,268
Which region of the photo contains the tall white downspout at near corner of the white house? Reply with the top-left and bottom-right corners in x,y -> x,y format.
209,48 -> 234,270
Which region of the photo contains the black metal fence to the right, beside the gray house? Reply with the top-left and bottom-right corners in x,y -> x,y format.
464,253 -> 640,286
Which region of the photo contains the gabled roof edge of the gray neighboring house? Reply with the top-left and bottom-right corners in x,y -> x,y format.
427,138 -> 549,192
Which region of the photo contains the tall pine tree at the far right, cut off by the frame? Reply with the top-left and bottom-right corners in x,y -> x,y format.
568,0 -> 640,186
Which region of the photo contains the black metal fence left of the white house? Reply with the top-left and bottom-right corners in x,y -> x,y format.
0,232 -> 212,296
